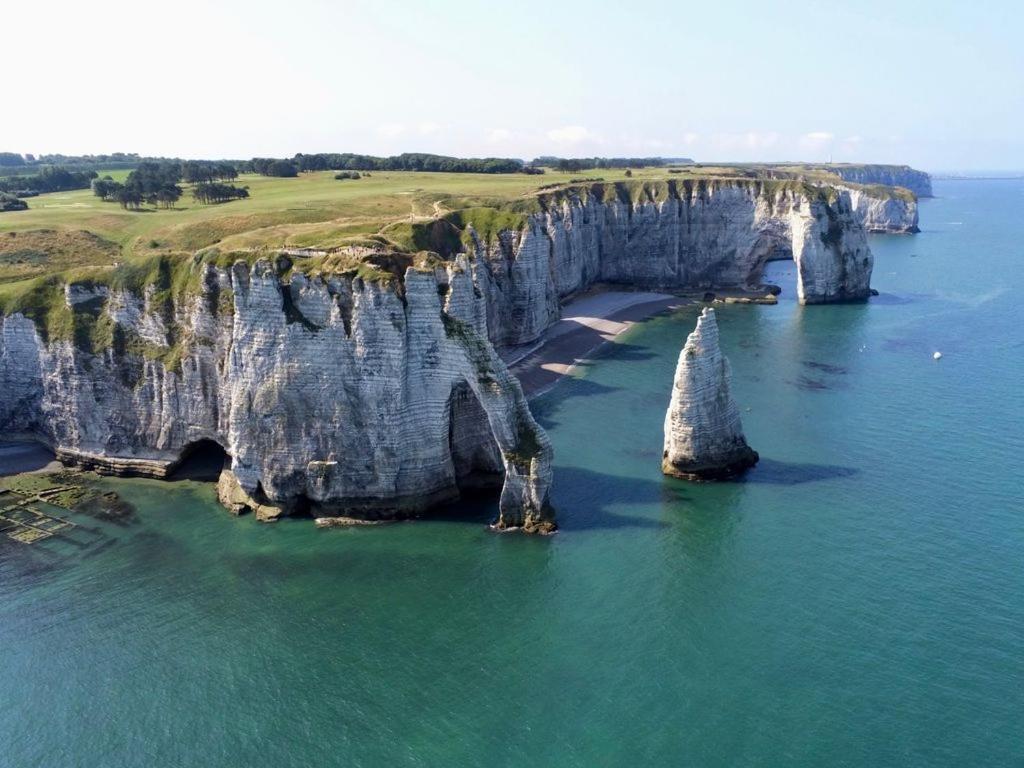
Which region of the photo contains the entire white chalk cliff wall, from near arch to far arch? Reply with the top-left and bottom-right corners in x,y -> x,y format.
0,179 -> 905,531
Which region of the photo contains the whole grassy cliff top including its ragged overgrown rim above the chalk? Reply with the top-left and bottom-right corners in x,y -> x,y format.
0,165 -> 912,327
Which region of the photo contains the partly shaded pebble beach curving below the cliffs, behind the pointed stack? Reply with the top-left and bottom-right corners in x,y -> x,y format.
502,291 -> 693,399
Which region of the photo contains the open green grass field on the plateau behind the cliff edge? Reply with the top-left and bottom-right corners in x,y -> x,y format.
0,166 -> 913,301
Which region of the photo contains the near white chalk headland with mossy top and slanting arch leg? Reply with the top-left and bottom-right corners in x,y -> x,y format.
0,257 -> 554,531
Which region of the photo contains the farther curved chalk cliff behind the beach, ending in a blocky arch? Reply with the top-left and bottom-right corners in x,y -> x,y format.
472,179 -> 873,346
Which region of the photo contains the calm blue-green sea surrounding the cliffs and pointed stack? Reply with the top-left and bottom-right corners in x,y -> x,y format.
0,181 -> 1024,768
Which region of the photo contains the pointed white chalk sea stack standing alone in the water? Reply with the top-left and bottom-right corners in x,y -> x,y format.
662,308 -> 758,480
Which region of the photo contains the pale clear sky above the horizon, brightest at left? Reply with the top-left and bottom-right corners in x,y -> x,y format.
0,0 -> 1024,170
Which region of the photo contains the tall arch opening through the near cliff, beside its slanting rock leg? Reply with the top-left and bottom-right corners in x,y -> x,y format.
449,381 -> 505,495
